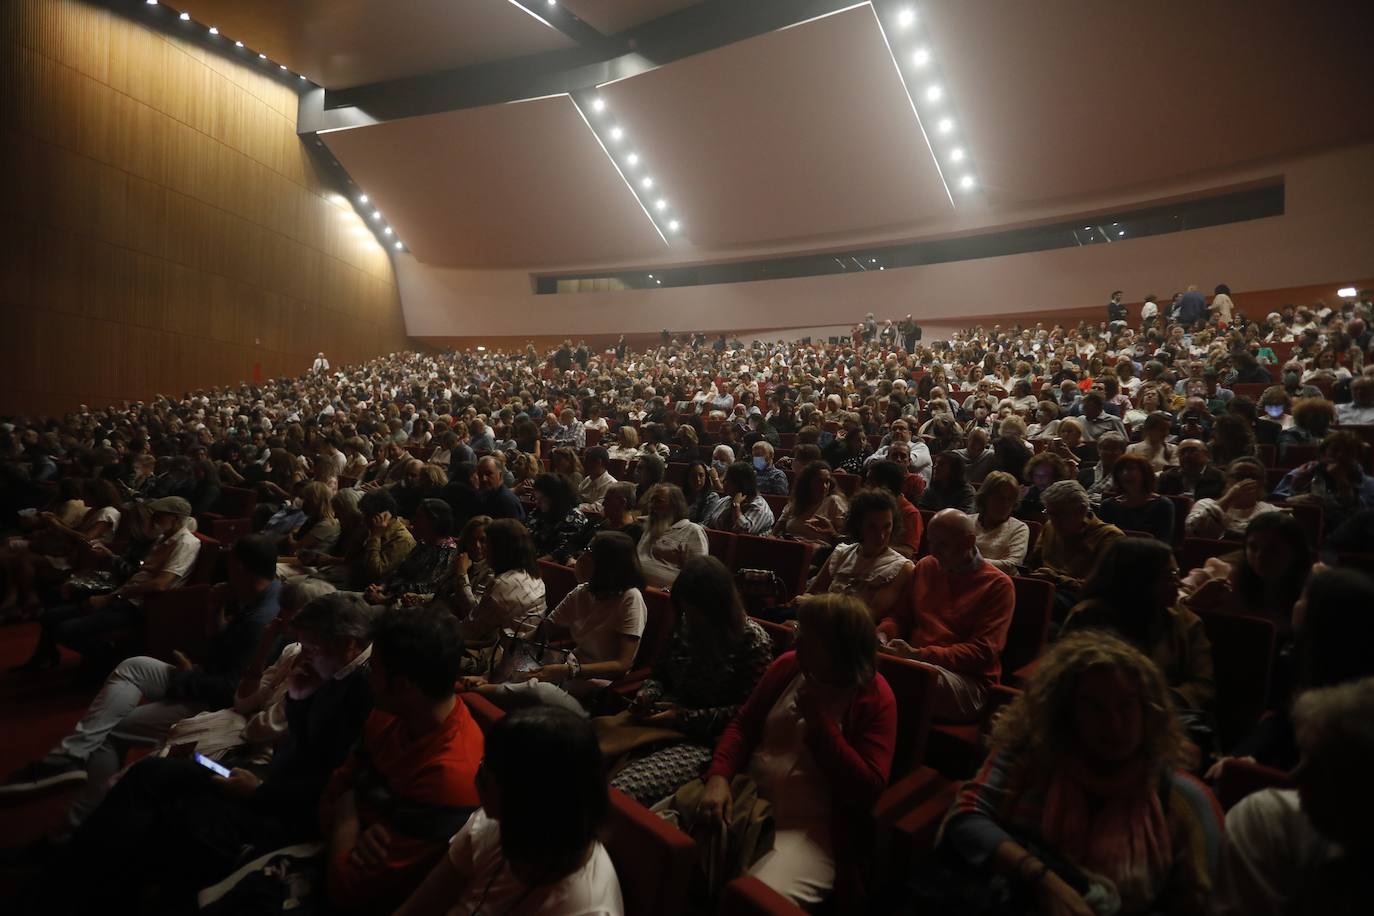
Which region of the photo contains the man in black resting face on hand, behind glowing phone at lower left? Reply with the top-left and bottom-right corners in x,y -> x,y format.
48,593 -> 374,912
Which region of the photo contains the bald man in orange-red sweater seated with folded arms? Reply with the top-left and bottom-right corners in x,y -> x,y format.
878,509 -> 1017,722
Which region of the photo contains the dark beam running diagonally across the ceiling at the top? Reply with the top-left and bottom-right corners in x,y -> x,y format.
297,0 -> 861,133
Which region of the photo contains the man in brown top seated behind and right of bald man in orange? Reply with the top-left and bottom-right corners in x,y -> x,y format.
1026,481 -> 1125,611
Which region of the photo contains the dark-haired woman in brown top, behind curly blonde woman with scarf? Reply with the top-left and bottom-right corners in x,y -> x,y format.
1062,537 -> 1216,710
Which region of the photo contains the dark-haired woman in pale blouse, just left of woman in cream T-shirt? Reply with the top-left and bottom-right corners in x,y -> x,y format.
452,519 -> 547,648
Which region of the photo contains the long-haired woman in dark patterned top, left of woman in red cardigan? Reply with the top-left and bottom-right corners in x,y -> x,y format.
611,556 -> 772,805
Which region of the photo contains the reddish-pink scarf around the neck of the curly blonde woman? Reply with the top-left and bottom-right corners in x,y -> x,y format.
1040,758 -> 1173,912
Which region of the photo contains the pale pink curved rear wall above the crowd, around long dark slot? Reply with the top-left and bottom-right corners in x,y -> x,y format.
397,143 -> 1374,338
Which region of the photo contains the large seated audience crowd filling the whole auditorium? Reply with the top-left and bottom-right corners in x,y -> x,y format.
0,291 -> 1374,912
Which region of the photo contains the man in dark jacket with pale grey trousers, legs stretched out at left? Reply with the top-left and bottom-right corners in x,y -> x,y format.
0,536 -> 282,834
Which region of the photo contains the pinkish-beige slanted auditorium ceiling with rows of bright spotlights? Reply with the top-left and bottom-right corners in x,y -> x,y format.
177,0 -> 1374,269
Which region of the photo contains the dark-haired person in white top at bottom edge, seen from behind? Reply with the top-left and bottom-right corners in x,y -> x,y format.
396,707 -> 624,916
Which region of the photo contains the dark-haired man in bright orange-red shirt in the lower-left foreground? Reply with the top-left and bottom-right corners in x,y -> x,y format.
320,608 -> 482,912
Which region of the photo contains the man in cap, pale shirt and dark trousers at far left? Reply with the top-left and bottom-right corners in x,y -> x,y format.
21,496 -> 201,673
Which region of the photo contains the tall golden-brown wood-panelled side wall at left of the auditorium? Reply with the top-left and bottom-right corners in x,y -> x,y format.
0,0 -> 408,413
